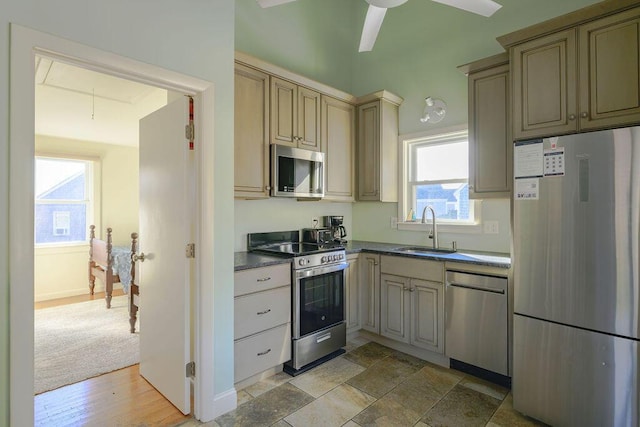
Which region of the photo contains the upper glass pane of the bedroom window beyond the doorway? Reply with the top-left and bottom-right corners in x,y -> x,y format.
36,158 -> 87,201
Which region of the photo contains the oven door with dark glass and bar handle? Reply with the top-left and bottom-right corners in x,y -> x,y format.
293,262 -> 348,339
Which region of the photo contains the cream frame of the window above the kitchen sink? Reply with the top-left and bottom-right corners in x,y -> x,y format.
397,126 -> 482,234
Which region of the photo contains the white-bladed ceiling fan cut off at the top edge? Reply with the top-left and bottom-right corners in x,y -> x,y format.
257,0 -> 502,52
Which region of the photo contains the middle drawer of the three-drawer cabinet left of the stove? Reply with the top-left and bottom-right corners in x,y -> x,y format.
234,286 -> 291,339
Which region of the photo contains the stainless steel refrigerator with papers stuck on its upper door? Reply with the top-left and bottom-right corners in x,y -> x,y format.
512,127 -> 640,427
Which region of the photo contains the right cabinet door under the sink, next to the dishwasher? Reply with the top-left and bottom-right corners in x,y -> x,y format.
411,279 -> 444,353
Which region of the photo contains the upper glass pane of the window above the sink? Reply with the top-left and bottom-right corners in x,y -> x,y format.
415,141 -> 469,181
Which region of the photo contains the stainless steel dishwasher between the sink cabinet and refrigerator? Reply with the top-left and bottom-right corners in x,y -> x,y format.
445,270 -> 509,376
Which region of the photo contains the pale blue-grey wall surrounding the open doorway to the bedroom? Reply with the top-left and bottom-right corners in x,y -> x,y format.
0,0 -> 235,426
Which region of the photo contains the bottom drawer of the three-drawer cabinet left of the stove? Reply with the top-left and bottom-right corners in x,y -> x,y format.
233,323 -> 291,382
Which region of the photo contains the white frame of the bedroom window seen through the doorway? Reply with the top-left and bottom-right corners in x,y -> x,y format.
33,151 -> 102,248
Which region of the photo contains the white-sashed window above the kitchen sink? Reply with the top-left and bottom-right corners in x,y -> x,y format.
399,130 -> 476,225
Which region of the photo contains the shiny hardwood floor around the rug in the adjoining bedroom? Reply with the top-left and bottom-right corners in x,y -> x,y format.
34,290 -> 191,426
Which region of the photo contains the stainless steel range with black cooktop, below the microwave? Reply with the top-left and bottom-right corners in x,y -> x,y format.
248,231 -> 348,375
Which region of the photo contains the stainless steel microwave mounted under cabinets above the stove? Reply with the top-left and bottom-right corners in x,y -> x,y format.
271,144 -> 324,199
